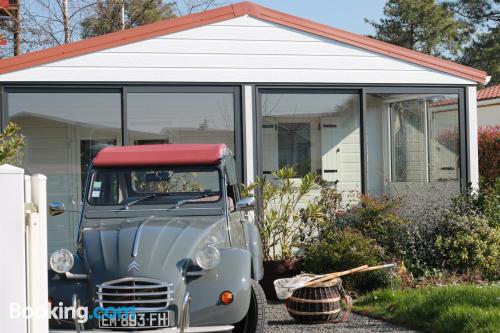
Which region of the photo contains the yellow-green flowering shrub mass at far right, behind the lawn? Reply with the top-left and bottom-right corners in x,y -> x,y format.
399,182 -> 500,278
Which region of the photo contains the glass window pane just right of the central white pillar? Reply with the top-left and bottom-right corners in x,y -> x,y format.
259,88 -> 361,191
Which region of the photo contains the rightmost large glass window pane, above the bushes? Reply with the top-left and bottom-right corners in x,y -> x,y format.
366,93 -> 460,195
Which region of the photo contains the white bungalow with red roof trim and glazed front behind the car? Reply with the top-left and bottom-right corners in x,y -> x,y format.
0,2 -> 488,250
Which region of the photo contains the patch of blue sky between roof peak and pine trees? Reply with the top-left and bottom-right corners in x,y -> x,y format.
242,0 -> 385,35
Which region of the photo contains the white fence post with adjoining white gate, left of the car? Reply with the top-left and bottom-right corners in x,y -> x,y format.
0,164 -> 48,333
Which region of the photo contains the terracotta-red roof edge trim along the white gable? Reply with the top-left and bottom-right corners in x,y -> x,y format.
0,2 -> 487,83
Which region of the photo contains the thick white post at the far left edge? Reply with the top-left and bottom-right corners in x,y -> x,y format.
0,164 -> 27,333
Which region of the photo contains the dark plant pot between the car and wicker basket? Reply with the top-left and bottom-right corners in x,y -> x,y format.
259,258 -> 300,300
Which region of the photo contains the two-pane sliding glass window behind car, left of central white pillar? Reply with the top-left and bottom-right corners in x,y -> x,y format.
8,87 -> 241,251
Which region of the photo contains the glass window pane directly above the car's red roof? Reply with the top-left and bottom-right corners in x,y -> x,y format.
127,92 -> 235,152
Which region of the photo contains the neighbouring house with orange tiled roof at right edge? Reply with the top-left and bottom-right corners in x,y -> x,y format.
477,84 -> 500,126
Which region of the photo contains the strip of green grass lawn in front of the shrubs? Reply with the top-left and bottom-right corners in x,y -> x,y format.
354,285 -> 500,333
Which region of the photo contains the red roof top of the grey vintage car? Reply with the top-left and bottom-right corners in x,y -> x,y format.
93,144 -> 228,167
